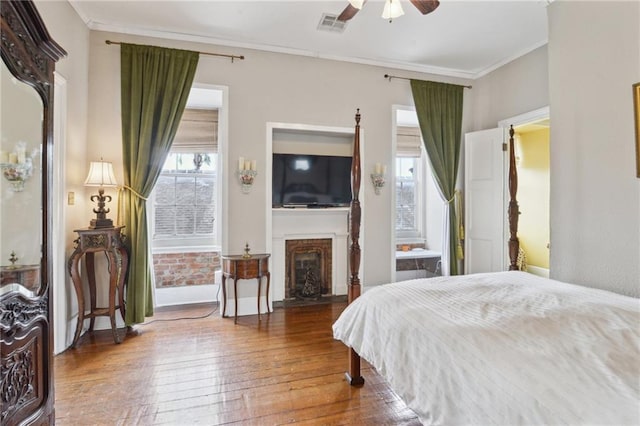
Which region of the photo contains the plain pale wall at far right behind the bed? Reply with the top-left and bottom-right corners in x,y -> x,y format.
548,1 -> 640,296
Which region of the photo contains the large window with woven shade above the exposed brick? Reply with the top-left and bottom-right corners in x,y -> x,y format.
152,104 -> 220,249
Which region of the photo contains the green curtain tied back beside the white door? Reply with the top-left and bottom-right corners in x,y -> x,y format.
411,80 -> 464,275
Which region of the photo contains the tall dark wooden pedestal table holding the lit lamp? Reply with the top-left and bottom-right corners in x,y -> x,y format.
69,226 -> 129,347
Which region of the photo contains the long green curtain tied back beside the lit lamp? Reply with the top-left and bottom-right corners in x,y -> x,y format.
120,43 -> 199,326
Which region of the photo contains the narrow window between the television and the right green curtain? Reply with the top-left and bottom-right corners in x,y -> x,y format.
395,126 -> 424,238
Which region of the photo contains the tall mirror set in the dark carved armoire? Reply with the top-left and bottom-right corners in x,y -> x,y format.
0,58 -> 44,295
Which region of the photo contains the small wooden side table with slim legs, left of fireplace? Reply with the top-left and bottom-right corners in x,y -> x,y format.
221,254 -> 271,323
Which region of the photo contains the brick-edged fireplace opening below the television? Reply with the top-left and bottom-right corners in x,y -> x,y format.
285,238 -> 332,300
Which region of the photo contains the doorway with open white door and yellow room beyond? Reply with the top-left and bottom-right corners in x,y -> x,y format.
465,107 -> 550,276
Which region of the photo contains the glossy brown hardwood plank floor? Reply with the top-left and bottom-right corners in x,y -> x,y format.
54,303 -> 420,425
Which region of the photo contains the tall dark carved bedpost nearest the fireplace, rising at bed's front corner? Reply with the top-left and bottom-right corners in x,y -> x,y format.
345,108 -> 364,386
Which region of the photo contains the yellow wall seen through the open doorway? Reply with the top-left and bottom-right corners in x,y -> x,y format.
516,128 -> 549,269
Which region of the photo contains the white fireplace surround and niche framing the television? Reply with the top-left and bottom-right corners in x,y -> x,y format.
264,122 -> 365,302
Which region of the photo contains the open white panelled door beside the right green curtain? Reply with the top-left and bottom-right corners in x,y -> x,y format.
464,128 -> 507,274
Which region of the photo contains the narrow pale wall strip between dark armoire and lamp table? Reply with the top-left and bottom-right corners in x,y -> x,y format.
35,1 -> 90,353
